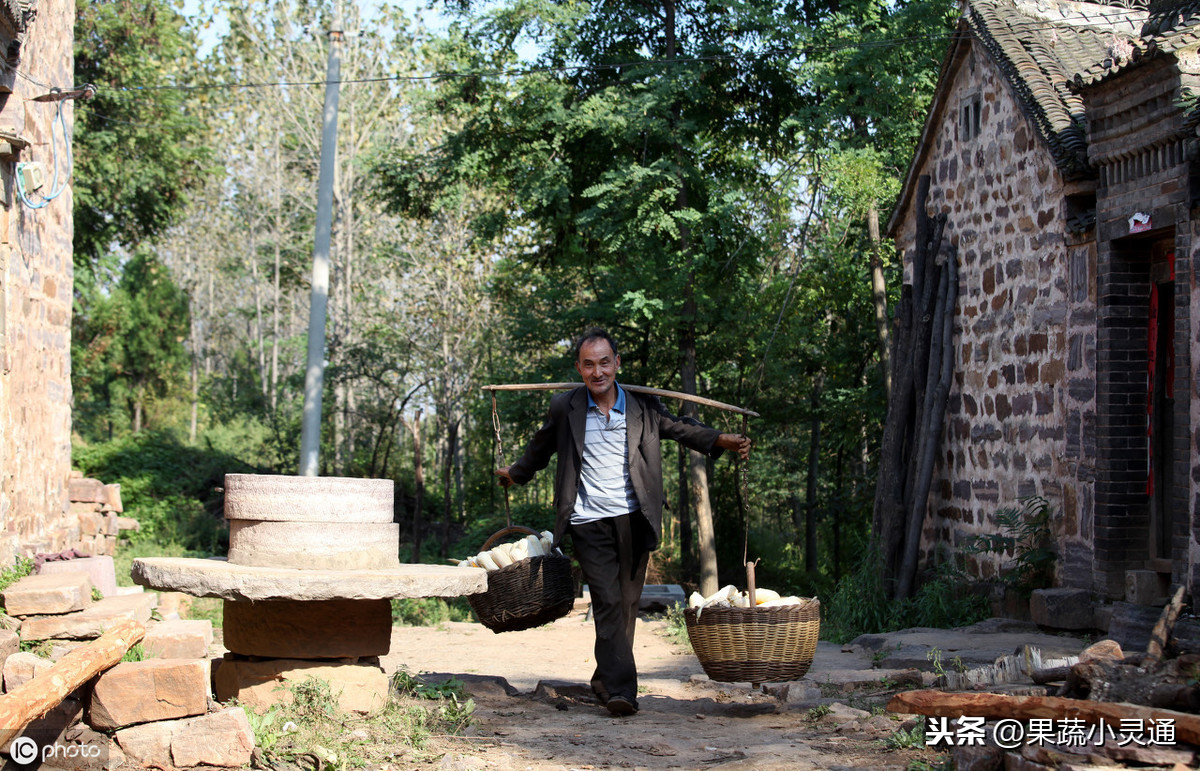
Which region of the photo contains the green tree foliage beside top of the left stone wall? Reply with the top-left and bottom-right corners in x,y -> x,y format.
72,0 -> 210,269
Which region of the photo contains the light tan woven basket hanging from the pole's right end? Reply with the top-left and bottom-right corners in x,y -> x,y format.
684,599 -> 821,685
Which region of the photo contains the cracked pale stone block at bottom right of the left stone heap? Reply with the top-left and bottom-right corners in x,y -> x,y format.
113,706 -> 254,769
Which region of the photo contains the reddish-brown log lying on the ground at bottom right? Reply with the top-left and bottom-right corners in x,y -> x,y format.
888,691 -> 1200,745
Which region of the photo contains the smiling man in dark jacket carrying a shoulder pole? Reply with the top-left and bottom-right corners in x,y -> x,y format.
496,328 -> 750,717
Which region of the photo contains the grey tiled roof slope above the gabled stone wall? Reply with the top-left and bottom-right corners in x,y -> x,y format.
964,0 -> 1146,179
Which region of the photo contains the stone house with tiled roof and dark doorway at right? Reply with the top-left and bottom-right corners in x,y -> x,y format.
888,0 -> 1200,612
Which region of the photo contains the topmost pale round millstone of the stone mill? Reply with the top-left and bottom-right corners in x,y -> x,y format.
224,474 -> 396,524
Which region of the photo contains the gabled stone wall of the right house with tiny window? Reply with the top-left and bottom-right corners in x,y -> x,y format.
895,43 -> 1097,586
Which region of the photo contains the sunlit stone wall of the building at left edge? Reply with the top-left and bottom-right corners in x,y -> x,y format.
0,0 -> 78,564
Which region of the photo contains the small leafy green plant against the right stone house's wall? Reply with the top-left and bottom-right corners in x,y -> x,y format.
962,495 -> 1057,597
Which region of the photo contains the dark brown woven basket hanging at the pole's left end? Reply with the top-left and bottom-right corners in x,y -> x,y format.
467,525 -> 575,633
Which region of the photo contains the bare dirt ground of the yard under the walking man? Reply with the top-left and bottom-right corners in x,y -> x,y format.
383,612 -> 940,771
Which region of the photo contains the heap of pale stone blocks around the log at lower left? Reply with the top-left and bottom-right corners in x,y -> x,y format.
0,560 -> 254,769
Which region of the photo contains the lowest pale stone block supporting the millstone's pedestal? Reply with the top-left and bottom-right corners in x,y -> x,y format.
212,653 -> 388,712
